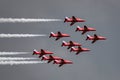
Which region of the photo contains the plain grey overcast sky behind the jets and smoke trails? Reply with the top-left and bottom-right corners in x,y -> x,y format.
0,0 -> 120,80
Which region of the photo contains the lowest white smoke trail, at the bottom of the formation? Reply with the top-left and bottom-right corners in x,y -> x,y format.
0,61 -> 46,65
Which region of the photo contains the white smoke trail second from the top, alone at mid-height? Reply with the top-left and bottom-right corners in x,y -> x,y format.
0,34 -> 46,38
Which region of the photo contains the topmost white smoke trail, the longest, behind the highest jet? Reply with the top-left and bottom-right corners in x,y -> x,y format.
0,18 -> 62,23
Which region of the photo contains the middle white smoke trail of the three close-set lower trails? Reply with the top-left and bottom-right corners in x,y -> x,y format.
0,57 -> 39,61
